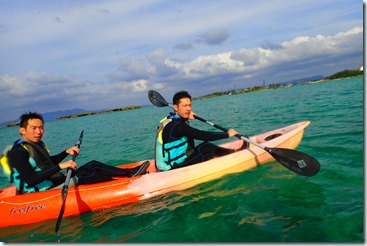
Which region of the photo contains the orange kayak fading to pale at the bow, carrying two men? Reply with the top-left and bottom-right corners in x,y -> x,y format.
0,121 -> 310,227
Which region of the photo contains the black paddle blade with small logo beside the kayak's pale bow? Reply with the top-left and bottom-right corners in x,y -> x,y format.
266,148 -> 320,176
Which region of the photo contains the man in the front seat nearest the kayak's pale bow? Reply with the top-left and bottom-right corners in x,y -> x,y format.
155,91 -> 246,171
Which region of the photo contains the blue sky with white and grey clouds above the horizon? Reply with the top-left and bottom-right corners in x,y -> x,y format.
0,0 -> 364,122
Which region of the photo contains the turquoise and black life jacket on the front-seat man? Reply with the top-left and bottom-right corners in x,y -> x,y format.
155,114 -> 188,171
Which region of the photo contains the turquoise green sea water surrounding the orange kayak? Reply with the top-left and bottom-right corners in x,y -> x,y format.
0,77 -> 365,242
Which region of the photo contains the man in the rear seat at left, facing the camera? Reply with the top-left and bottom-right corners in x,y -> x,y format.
1,112 -> 149,194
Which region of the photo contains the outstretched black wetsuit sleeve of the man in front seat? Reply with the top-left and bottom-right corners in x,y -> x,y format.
177,122 -> 229,141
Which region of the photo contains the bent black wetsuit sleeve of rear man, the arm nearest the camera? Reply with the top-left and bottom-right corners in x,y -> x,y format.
9,148 -> 61,185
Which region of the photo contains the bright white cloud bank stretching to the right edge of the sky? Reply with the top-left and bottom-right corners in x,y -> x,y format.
166,27 -> 363,82
